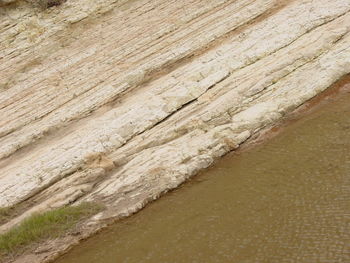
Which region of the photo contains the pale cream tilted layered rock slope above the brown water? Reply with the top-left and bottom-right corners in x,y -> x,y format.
0,0 -> 350,262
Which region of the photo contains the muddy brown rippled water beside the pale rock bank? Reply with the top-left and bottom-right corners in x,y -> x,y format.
57,86 -> 350,263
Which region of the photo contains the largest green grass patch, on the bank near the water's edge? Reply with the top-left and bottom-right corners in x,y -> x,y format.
0,203 -> 102,255
